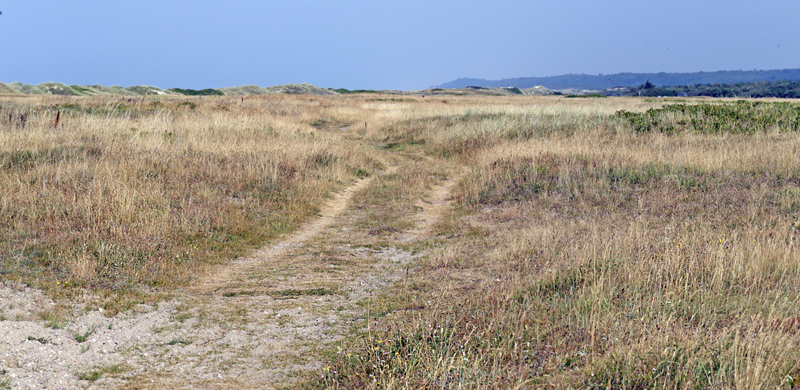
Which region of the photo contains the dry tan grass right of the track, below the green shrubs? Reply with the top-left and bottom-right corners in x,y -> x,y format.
319,96 -> 800,388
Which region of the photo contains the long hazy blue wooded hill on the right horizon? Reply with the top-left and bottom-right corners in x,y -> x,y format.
438,69 -> 800,90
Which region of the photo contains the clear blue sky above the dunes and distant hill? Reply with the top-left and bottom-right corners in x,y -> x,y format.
0,0 -> 800,89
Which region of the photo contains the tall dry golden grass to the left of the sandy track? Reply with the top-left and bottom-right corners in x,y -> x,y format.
0,97 -> 379,289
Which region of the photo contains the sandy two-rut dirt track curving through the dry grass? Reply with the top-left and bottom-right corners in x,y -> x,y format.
0,159 -> 457,389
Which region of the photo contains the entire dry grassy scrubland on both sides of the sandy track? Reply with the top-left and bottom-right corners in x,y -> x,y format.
0,95 -> 800,388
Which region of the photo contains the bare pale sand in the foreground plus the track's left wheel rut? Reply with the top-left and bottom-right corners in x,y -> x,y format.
0,178 -> 382,389
